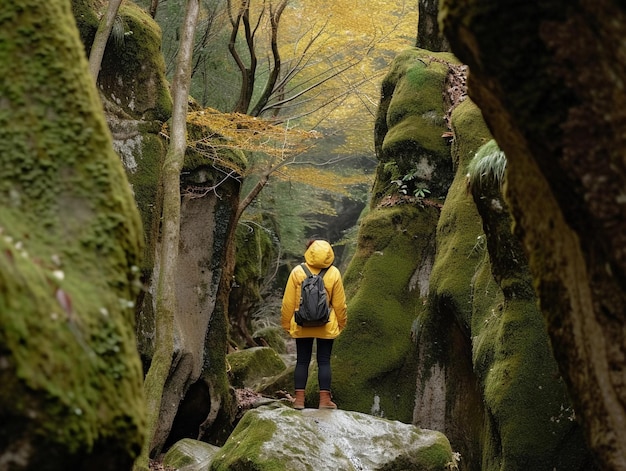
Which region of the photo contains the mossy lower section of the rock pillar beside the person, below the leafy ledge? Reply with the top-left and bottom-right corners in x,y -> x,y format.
332,206 -> 438,422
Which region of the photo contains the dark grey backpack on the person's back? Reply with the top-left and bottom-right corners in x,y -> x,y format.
295,263 -> 330,327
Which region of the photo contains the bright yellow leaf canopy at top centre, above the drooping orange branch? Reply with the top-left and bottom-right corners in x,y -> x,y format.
281,0 -> 418,154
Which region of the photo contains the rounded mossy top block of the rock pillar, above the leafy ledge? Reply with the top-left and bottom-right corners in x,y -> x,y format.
372,48 -> 458,205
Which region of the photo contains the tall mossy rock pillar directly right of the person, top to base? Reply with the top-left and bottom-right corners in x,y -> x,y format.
332,48 -> 457,422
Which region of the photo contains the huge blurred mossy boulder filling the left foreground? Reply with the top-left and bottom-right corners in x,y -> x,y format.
0,0 -> 145,470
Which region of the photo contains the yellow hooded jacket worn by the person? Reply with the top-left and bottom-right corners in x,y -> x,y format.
281,240 -> 348,339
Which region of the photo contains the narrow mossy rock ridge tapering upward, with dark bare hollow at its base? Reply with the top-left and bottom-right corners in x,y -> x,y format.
413,100 -> 490,469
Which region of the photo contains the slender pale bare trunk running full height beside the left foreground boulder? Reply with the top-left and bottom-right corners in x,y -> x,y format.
135,0 -> 199,470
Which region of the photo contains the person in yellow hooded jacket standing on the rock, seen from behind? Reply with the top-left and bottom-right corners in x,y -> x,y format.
281,240 -> 348,409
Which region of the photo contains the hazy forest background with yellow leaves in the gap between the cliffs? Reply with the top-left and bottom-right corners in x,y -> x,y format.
138,0 -> 418,263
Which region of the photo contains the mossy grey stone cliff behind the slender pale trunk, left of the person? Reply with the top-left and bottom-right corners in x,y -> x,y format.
73,0 -> 245,458
